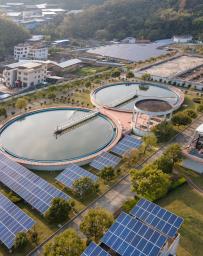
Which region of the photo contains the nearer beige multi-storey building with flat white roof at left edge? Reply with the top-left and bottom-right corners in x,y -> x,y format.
3,61 -> 47,88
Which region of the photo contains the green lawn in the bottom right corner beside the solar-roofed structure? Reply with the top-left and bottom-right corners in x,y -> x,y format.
158,185 -> 203,256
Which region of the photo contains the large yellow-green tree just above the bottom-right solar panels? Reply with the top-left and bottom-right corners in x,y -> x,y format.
131,165 -> 171,201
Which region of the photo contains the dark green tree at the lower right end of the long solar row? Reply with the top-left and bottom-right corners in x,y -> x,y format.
45,198 -> 71,223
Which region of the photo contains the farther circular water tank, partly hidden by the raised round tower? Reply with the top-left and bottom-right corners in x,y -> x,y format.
91,82 -> 181,112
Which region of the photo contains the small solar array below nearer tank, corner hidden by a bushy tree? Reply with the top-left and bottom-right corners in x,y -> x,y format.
56,164 -> 98,188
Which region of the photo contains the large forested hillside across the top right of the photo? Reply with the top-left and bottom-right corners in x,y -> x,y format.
58,0 -> 203,40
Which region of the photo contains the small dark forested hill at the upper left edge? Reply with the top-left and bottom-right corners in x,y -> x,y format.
0,17 -> 29,57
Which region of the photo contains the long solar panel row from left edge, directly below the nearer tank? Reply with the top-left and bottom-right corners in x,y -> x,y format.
0,153 -> 70,214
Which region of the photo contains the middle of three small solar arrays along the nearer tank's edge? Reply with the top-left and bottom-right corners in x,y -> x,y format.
90,152 -> 121,171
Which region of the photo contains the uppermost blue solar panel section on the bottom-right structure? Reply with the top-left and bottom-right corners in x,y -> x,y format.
130,199 -> 183,238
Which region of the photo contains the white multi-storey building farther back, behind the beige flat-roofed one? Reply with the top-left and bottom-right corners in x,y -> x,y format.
14,43 -> 48,60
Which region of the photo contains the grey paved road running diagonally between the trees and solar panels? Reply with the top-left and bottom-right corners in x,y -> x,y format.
28,115 -> 203,256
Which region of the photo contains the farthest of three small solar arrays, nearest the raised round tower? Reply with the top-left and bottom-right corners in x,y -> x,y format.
111,135 -> 142,156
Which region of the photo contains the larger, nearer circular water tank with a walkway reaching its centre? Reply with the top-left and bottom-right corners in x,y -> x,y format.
0,107 -> 121,170
